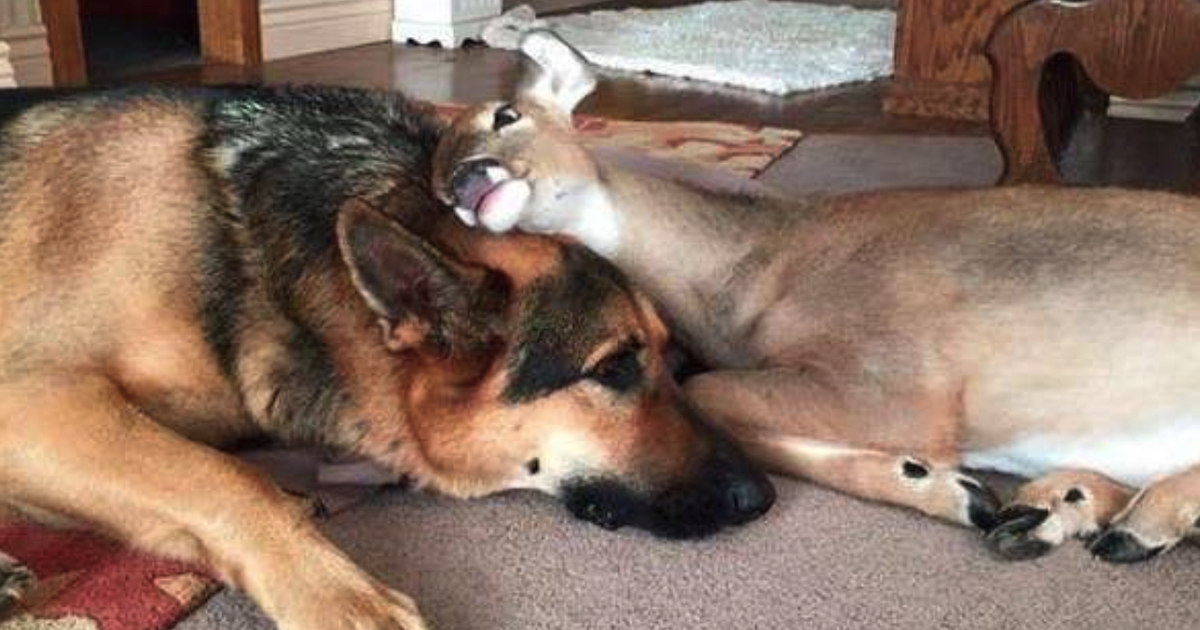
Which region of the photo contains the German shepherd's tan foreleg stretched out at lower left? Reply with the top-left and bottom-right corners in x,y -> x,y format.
0,376 -> 425,630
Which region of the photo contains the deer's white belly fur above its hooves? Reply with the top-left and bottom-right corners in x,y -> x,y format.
962,418 -> 1200,486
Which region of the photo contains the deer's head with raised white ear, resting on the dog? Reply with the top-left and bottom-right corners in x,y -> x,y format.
433,30 -> 602,243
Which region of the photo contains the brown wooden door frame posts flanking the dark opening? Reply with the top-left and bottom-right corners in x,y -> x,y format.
40,0 -> 263,85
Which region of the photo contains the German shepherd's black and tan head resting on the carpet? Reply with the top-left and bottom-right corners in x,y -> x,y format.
338,204 -> 774,538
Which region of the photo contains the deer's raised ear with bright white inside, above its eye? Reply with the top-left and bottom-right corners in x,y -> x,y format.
517,29 -> 596,115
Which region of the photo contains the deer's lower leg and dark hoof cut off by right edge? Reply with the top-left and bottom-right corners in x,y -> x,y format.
1088,466 -> 1200,563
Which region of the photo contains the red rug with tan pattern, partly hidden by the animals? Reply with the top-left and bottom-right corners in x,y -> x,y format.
0,106 -> 800,630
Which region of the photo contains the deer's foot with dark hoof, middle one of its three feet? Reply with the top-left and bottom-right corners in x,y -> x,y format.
988,469 -> 1133,560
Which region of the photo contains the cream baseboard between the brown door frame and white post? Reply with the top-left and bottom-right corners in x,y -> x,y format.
262,0 -> 391,60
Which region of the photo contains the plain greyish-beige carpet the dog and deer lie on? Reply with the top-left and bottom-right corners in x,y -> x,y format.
180,136 -> 1200,630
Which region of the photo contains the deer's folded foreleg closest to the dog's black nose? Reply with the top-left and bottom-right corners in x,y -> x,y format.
684,368 -> 997,529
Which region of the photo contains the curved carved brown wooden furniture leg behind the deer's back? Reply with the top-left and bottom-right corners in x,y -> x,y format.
988,0 -> 1200,184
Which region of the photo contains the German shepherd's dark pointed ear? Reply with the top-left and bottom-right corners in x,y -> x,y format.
337,200 -> 473,352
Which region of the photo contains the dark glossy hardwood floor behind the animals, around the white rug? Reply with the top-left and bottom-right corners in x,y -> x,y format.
134,39 -> 1200,190
